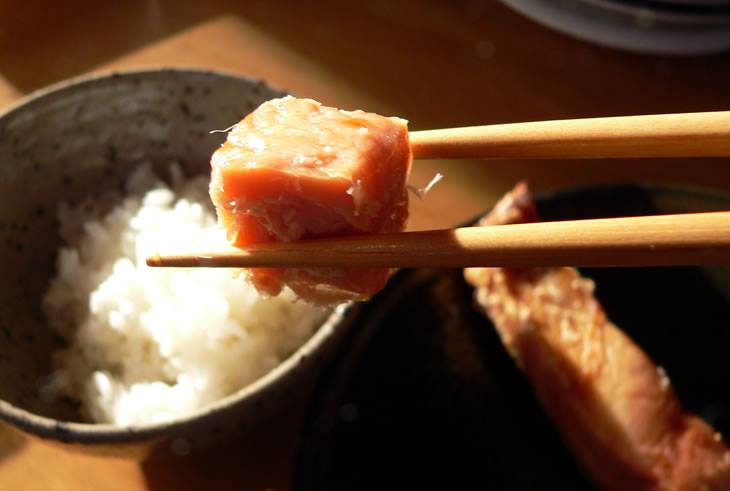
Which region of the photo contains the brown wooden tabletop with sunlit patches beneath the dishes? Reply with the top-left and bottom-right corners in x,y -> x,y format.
0,0 -> 730,491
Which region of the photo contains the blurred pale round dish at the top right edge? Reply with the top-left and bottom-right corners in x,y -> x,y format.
502,0 -> 730,55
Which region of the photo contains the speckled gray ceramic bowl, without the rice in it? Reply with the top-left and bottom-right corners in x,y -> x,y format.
0,70 -> 352,457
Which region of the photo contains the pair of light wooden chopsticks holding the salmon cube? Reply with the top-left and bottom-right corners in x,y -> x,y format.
147,111 -> 730,268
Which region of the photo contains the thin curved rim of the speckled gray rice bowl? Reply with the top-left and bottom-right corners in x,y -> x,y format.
0,67 -> 355,444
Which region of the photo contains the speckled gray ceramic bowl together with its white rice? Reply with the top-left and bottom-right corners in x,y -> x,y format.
0,69 -> 353,456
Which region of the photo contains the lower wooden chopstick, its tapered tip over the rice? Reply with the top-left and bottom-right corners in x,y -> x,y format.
147,212 -> 730,268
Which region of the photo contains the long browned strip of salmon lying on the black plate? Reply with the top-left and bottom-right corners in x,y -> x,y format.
465,184 -> 730,491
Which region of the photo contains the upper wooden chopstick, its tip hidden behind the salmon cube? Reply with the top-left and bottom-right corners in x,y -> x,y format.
410,111 -> 730,159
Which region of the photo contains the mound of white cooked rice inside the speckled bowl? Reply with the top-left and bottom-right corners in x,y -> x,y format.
44,166 -> 325,425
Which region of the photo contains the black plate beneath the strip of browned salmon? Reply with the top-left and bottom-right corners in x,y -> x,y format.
294,186 -> 730,491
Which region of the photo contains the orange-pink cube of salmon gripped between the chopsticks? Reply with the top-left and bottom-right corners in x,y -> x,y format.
210,97 -> 412,304
